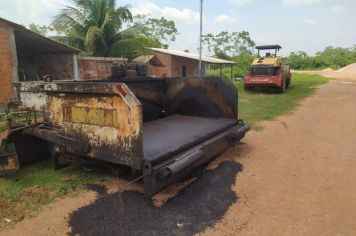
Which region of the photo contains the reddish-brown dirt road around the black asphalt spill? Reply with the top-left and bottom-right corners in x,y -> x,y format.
0,82 -> 356,236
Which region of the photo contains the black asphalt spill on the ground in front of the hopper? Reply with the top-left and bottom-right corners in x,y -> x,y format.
69,161 -> 242,236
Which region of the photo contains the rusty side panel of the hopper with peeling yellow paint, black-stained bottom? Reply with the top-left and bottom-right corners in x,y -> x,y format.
47,83 -> 143,169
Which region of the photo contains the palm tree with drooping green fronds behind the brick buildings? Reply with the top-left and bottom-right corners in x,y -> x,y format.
52,0 -> 135,56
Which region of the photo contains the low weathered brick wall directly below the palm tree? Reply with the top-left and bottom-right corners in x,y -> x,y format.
78,57 -> 127,80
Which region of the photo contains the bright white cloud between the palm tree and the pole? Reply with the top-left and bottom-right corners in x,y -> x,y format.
131,0 -> 199,23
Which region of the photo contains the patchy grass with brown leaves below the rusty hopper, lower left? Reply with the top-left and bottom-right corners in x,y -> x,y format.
0,160 -> 105,229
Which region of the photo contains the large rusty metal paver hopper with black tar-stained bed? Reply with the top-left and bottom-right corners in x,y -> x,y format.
7,77 -> 249,197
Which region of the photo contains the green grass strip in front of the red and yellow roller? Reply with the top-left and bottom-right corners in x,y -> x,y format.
236,74 -> 329,130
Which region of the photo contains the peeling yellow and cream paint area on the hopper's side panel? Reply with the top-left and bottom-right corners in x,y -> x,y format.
47,90 -> 142,149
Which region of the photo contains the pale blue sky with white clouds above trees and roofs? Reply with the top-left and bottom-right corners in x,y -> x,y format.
0,0 -> 356,55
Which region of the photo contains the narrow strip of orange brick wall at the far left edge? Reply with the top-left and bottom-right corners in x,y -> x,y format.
0,22 -> 13,106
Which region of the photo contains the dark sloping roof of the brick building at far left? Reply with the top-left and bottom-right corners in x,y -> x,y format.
0,18 -> 81,53
